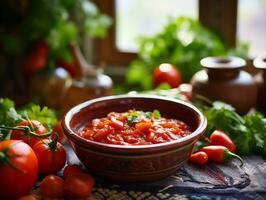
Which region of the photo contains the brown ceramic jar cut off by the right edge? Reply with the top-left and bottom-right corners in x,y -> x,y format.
253,57 -> 266,113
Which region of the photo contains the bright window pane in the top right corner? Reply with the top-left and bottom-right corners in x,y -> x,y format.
237,0 -> 266,57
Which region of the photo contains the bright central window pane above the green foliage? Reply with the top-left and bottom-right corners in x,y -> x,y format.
115,0 -> 198,52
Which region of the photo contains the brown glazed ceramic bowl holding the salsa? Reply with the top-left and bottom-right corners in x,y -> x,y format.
62,95 -> 207,182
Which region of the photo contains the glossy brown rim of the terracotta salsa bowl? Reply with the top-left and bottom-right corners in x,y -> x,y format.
62,94 -> 207,153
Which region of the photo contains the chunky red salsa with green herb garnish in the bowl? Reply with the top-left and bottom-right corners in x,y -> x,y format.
80,110 -> 191,145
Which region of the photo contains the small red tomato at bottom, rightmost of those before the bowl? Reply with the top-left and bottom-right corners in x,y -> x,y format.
64,173 -> 95,198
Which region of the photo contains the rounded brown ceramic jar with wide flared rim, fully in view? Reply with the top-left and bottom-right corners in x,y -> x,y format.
191,57 -> 257,114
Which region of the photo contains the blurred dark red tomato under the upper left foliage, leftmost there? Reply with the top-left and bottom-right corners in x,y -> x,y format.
23,41 -> 49,74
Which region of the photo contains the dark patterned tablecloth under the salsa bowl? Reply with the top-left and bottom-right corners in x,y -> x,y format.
34,146 -> 266,200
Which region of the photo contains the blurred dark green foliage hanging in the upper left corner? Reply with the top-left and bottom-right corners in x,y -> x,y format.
0,0 -> 111,60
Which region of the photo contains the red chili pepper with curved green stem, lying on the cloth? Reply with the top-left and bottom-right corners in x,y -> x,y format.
200,145 -> 243,166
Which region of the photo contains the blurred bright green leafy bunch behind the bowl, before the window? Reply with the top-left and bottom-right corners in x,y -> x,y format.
126,17 -> 248,90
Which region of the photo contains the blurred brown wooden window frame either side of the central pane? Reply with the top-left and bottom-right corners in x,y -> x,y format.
93,0 -> 238,66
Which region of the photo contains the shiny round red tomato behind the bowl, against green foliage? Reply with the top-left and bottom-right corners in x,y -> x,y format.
153,63 -> 182,88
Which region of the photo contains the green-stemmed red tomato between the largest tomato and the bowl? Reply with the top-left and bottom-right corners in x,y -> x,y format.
33,139 -> 66,174
